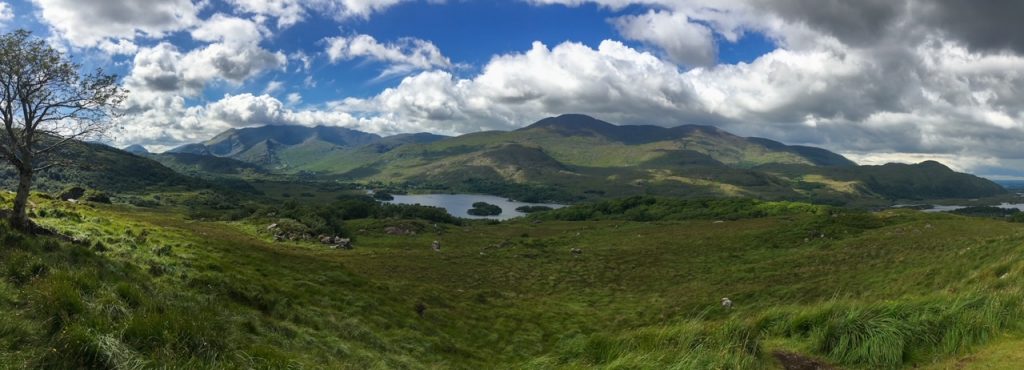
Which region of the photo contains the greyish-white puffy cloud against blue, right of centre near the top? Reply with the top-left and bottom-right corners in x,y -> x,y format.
613,10 -> 717,67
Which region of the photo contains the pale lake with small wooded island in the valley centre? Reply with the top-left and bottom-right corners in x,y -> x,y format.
387,194 -> 564,219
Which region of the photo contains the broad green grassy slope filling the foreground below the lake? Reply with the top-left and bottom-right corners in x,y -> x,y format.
0,191 -> 1024,369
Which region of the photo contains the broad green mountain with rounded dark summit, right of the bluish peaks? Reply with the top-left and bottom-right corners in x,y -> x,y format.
316,115 -> 1005,203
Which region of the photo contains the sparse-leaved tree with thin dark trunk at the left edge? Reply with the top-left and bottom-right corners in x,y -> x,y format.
0,30 -> 126,229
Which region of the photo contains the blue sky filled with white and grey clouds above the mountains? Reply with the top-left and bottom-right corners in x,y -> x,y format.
0,0 -> 1024,178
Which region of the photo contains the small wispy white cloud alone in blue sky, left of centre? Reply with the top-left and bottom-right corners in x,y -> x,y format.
326,35 -> 453,75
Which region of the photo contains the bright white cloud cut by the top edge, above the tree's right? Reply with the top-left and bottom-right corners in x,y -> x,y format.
33,0 -> 199,47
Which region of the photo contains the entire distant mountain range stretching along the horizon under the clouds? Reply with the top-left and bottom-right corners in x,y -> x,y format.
142,115 -> 1006,203
